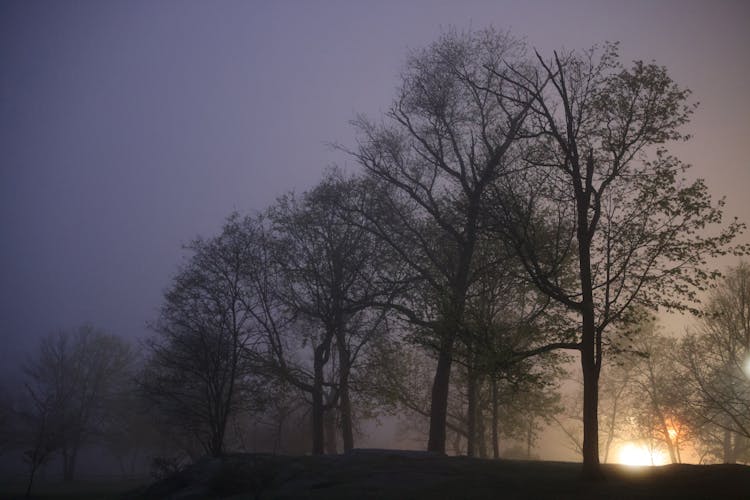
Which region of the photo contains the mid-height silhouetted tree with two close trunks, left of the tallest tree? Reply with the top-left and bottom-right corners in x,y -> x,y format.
255,172 -> 392,453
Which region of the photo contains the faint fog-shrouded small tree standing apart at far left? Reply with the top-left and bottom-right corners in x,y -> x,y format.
24,325 -> 134,481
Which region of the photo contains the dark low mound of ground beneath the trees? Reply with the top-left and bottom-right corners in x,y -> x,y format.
124,450 -> 750,500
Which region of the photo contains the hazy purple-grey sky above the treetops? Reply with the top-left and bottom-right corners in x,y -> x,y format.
0,0 -> 750,376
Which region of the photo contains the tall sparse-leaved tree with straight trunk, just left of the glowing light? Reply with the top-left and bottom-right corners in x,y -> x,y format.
490,45 -> 743,479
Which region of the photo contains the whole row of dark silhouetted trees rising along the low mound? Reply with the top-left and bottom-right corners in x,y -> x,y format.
2,29 -> 750,484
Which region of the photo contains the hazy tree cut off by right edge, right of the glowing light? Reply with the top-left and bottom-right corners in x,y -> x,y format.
679,262 -> 750,463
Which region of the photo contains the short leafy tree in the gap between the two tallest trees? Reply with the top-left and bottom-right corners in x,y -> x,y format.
455,264 -> 570,458
